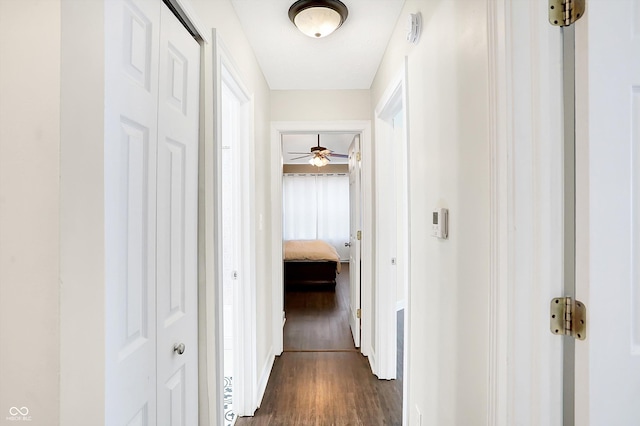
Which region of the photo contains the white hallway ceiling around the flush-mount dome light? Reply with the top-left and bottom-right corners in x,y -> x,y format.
231,0 -> 405,90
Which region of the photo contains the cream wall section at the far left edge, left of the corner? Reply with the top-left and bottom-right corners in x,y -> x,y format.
0,0 -> 60,426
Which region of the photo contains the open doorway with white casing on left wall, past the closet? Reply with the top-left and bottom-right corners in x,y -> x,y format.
215,39 -> 257,426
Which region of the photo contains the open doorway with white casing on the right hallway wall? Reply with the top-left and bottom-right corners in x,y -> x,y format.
375,66 -> 411,419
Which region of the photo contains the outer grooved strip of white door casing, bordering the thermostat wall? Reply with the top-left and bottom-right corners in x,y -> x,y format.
486,0 -> 513,426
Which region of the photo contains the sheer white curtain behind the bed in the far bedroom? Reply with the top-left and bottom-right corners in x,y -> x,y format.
282,173 -> 349,260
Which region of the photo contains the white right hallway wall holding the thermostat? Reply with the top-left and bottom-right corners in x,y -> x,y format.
371,0 -> 489,425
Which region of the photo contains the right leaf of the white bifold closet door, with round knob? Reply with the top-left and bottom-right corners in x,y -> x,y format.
156,2 -> 200,426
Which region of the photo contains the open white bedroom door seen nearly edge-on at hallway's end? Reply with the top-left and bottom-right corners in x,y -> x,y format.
349,135 -> 362,347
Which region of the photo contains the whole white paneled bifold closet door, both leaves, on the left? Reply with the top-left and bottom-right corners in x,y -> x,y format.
105,0 -> 199,425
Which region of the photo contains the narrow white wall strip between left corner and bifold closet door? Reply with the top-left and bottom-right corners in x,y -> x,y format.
59,0 -> 105,425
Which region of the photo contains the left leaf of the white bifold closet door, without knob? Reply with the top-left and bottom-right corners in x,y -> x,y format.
105,0 -> 160,425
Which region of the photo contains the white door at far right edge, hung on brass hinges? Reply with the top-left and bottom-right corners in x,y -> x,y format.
575,0 -> 640,425
